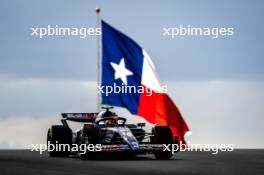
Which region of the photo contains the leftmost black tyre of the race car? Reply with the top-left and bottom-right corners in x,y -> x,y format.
47,125 -> 72,157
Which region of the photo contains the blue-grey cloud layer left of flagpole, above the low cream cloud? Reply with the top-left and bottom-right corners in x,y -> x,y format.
0,79 -> 96,119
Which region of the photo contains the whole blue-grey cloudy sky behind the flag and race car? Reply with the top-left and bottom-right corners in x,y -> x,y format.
0,0 -> 264,148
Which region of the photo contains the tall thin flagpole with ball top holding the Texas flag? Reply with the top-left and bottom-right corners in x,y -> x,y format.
95,7 -> 101,112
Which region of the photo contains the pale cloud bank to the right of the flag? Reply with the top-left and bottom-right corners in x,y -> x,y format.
169,81 -> 264,148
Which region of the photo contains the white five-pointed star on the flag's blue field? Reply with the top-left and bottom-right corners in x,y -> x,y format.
110,58 -> 133,85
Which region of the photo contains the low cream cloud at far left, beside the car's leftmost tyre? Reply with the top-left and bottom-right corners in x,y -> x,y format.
0,116 -> 59,149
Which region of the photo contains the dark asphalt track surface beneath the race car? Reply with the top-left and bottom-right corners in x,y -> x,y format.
0,149 -> 264,175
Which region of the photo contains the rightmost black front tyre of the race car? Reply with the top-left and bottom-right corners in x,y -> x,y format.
152,126 -> 173,160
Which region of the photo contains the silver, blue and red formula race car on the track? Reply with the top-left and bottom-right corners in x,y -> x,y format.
47,107 -> 177,159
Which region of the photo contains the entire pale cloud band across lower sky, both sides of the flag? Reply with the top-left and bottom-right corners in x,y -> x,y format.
0,79 -> 264,148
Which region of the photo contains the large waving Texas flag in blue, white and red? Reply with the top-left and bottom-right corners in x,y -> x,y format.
101,21 -> 189,141
